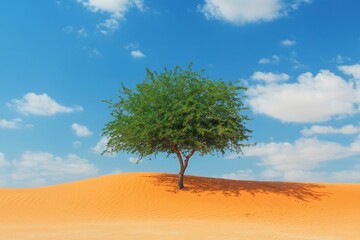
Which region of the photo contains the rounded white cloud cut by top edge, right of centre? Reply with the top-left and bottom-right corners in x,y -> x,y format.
199,0 -> 309,25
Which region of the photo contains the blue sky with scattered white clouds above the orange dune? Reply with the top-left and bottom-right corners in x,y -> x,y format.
0,0 -> 360,187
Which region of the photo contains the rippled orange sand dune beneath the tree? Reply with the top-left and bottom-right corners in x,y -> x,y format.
0,173 -> 360,240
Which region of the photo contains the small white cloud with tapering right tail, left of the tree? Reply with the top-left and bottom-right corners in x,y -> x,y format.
9,92 -> 83,116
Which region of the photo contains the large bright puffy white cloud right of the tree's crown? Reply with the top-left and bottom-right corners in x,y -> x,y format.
248,70 -> 360,123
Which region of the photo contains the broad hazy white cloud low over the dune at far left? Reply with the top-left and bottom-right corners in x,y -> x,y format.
0,151 -> 98,187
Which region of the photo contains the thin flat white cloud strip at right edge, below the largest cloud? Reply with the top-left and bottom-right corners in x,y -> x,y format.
301,124 -> 360,136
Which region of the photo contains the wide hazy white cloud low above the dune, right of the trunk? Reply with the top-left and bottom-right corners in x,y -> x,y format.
226,137 -> 360,181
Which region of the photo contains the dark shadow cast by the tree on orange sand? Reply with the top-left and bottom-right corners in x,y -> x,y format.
146,173 -> 329,202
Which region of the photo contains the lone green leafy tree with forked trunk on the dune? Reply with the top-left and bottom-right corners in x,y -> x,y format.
103,64 -> 251,189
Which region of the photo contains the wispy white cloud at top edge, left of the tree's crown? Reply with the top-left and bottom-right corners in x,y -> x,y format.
77,0 -> 144,35
